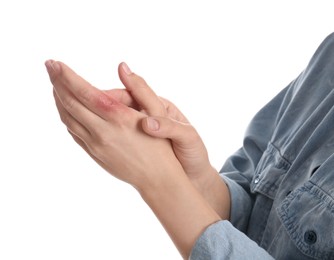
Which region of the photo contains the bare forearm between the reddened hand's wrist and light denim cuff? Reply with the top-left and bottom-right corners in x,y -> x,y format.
139,164 -> 220,259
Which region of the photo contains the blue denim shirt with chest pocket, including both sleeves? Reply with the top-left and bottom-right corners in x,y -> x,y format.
190,34 -> 334,260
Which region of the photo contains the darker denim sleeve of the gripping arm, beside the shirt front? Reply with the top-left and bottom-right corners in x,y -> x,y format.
220,82 -> 293,233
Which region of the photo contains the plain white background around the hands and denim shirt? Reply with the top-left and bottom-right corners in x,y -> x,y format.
0,0 -> 334,260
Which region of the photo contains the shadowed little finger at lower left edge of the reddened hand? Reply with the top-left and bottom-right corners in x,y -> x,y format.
53,91 -> 90,139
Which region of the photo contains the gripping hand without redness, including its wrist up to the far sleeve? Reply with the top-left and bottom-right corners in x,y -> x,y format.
105,63 -> 229,219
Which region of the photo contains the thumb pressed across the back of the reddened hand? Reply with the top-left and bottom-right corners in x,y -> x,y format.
142,117 -> 199,146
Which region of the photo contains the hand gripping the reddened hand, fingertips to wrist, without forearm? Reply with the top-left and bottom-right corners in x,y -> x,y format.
105,63 -> 217,186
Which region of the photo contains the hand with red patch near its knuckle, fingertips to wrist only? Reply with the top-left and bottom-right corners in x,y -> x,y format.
46,61 -> 182,189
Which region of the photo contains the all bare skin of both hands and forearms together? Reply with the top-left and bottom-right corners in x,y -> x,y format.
45,60 -> 229,259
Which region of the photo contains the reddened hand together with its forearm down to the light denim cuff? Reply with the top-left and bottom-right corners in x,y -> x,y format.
46,61 -> 220,259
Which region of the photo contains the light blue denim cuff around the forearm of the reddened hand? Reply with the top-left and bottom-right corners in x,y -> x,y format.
189,220 -> 274,260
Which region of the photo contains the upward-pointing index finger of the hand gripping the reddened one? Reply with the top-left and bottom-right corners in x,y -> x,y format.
118,62 -> 166,116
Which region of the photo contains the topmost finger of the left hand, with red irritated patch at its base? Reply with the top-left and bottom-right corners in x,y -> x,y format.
45,60 -> 119,119
